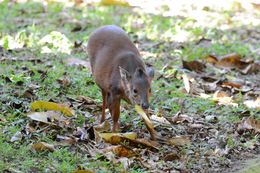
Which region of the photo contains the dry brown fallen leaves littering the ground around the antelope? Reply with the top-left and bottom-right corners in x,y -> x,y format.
1,1 -> 260,172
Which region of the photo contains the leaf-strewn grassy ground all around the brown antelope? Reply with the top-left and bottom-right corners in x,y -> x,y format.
0,0 -> 260,173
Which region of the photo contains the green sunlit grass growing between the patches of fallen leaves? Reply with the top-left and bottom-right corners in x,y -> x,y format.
0,1 -> 259,172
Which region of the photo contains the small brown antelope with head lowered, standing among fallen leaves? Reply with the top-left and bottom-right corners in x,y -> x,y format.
87,25 -> 154,138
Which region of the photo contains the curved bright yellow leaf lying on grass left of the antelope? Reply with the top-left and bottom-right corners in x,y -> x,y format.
31,100 -> 74,116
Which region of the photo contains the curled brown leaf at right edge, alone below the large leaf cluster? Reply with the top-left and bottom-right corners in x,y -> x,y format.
237,117 -> 260,134
